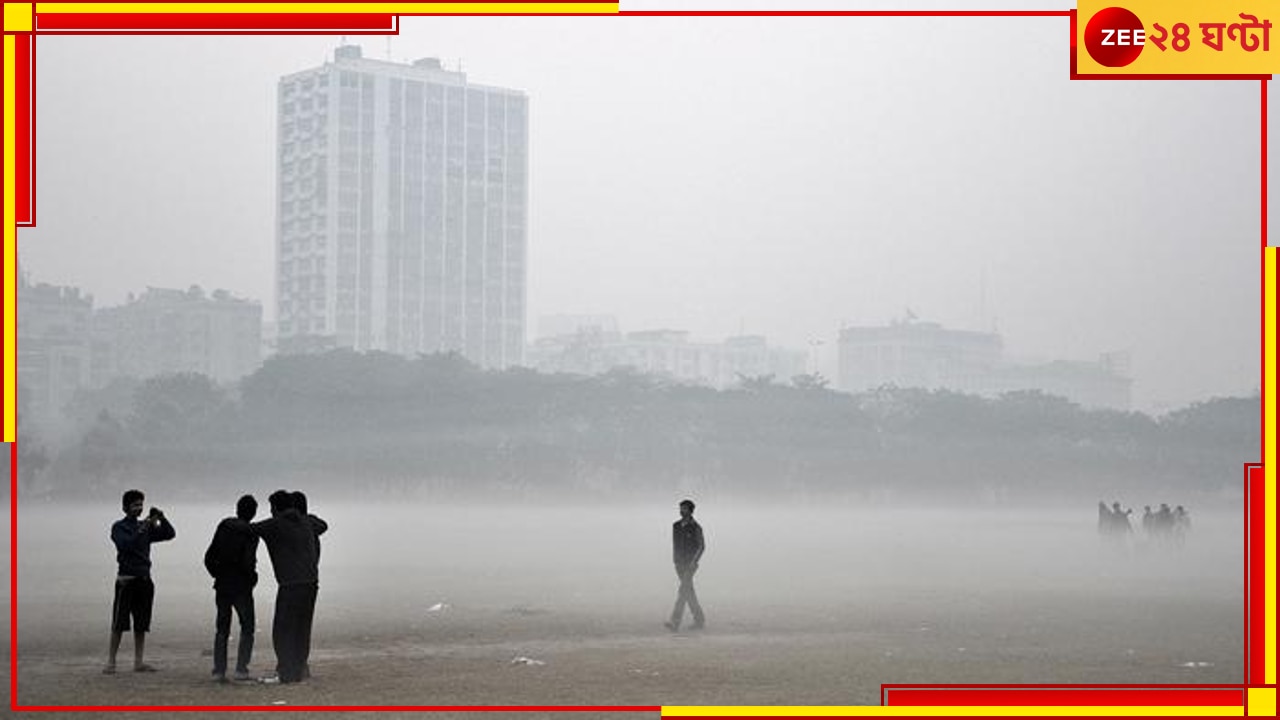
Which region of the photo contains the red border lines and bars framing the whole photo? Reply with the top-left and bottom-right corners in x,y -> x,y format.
6,5 -> 1280,714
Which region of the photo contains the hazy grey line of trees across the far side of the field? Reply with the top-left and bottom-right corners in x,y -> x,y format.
19,350 -> 1261,501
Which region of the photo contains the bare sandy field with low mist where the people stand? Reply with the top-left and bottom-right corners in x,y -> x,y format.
5,509 -> 1244,717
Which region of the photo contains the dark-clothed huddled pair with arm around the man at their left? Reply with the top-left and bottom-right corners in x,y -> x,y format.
251,489 -> 328,683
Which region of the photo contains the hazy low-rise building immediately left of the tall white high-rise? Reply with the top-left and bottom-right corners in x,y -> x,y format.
93,286 -> 262,383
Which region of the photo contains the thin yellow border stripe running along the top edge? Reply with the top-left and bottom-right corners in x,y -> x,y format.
36,3 -> 618,15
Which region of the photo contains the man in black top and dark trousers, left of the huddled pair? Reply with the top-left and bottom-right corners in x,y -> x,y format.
205,495 -> 257,683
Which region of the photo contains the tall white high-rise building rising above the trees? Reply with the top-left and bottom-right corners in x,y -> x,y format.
275,46 -> 529,368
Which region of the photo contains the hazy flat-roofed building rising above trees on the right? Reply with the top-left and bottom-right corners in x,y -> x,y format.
836,320 -> 1133,410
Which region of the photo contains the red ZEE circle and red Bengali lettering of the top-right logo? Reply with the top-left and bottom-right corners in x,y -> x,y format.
1084,8 -> 1271,68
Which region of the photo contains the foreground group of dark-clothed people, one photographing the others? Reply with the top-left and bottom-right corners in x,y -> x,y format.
104,489 -> 329,683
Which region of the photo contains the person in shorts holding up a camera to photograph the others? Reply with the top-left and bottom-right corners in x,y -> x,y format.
102,489 -> 178,675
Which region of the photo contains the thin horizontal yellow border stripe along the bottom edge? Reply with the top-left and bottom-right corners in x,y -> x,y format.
662,705 -> 1244,717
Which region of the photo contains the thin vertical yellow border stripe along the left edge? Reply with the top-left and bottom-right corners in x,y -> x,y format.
0,35 -> 18,442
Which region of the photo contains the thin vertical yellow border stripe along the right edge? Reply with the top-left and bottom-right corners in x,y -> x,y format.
1260,245 -> 1280,685
